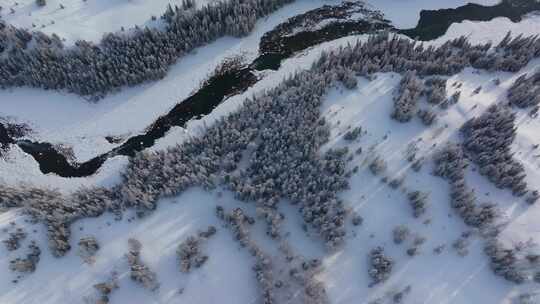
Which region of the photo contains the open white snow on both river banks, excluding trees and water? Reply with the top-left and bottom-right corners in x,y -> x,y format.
0,0 -> 540,304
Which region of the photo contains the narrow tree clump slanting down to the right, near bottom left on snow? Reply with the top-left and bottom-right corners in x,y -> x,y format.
126,239 -> 159,291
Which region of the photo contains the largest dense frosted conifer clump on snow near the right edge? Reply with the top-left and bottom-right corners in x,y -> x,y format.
461,105 -> 527,196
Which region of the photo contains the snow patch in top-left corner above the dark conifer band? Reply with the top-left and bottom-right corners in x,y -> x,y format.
0,0 -> 211,45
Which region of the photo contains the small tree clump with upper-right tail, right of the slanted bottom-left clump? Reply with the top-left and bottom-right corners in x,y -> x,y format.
176,226 -> 217,273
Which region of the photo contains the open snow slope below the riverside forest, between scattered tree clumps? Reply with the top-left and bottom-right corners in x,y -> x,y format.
0,60 -> 540,304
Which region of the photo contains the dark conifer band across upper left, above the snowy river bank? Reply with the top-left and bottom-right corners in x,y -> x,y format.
0,0 -> 293,99
